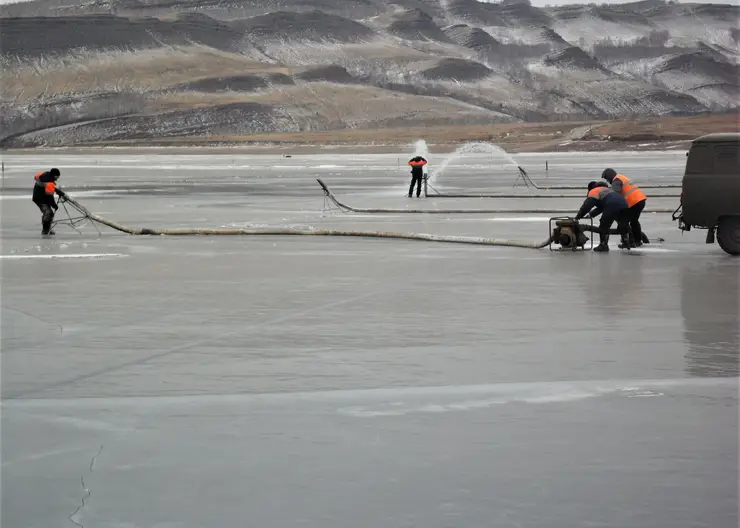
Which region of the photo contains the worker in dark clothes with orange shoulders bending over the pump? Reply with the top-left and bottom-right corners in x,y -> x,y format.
575,182 -> 630,251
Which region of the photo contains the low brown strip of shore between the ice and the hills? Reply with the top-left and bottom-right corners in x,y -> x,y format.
0,111 -> 740,155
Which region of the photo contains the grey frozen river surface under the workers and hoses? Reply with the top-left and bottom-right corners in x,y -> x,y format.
0,152 -> 740,528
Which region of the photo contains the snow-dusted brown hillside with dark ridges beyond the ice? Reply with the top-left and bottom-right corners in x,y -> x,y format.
0,0 -> 740,146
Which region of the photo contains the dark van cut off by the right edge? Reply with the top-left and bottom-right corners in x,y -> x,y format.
673,133 -> 740,255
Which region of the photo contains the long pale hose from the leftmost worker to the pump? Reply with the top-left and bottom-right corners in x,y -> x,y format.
59,190 -> 552,249
